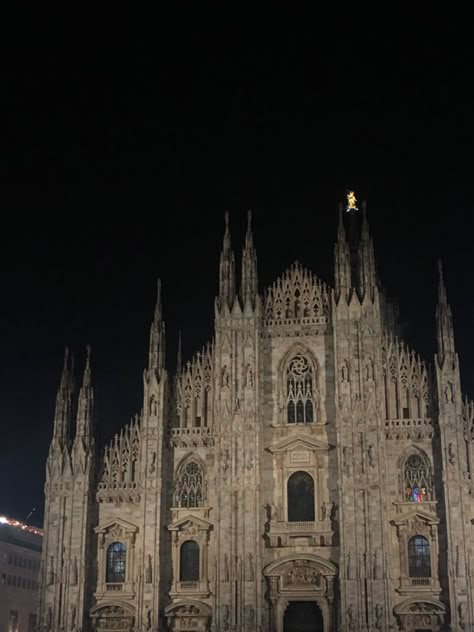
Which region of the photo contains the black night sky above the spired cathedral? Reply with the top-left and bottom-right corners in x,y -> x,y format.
0,3 -> 474,524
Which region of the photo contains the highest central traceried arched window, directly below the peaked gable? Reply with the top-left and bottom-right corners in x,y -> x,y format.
286,354 -> 314,424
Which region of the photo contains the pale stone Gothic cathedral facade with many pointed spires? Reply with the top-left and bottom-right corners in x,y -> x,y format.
38,207 -> 474,632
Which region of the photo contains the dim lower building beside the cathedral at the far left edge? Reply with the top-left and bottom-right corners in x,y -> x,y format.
0,516 -> 43,632
